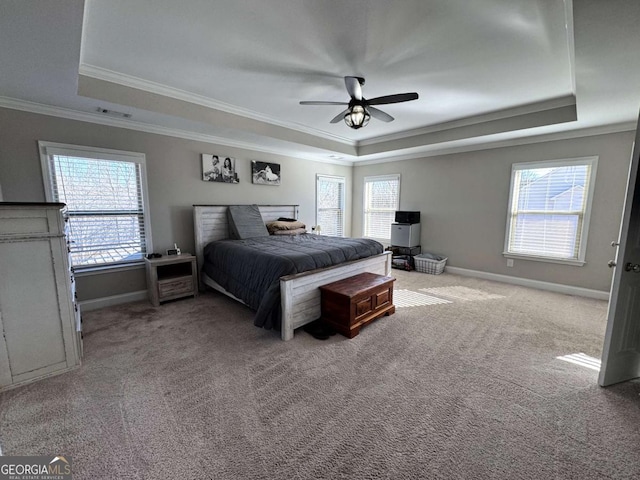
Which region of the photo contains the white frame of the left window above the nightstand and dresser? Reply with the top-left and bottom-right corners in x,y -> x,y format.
38,141 -> 153,273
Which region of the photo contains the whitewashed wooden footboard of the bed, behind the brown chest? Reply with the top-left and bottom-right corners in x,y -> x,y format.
280,252 -> 391,340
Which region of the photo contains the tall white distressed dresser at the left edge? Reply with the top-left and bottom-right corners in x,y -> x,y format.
0,203 -> 82,390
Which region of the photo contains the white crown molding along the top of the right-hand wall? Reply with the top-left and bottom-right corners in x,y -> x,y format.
354,122 -> 637,166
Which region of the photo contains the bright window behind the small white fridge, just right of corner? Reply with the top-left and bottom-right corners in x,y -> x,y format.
363,174 -> 400,241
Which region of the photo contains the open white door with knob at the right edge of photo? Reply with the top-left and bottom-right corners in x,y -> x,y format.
598,118 -> 640,387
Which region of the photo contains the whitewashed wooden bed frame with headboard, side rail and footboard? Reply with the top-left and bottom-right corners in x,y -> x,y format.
193,205 -> 391,340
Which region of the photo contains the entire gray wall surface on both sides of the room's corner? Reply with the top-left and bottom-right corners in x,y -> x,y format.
0,109 -> 633,300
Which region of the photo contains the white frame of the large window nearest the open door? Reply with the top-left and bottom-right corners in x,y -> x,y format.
502,156 -> 598,266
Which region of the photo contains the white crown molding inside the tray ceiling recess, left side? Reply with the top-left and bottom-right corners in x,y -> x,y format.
78,63 -> 358,147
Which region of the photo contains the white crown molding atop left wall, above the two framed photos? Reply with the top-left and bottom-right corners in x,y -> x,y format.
0,96 -> 353,167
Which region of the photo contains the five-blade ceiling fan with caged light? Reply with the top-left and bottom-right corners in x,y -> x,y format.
300,77 -> 418,130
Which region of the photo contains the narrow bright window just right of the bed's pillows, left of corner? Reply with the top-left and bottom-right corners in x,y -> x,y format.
316,175 -> 344,237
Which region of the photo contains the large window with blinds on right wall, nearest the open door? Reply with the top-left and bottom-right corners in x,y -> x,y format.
504,157 -> 598,265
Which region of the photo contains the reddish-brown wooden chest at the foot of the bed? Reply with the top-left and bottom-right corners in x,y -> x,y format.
320,273 -> 396,338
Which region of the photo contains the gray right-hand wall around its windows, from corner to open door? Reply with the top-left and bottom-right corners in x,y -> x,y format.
352,132 -> 633,291
